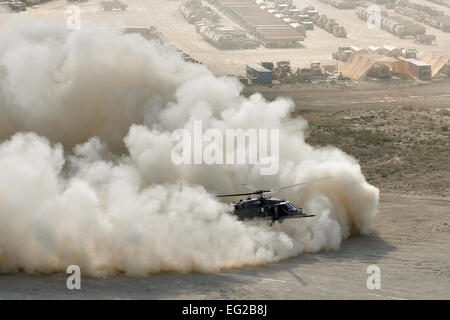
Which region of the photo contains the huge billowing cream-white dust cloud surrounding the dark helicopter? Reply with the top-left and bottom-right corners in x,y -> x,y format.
0,19 -> 378,276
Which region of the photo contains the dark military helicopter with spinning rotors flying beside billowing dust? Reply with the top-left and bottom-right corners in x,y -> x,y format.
217,177 -> 332,226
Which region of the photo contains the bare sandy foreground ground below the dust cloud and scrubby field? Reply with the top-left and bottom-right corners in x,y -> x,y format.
0,195 -> 450,299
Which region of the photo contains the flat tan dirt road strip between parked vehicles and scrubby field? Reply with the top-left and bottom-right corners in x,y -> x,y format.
244,81 -> 450,114
